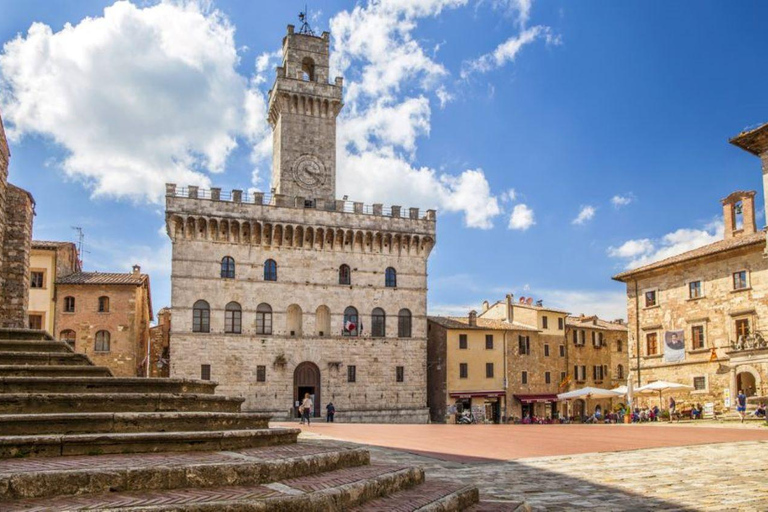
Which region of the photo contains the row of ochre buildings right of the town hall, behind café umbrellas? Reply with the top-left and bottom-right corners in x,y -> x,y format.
428,295 -> 627,421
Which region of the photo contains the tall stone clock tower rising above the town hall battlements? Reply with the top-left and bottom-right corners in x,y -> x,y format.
269,25 -> 343,201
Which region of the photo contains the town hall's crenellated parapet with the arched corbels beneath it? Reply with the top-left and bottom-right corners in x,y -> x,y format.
166,184 -> 436,257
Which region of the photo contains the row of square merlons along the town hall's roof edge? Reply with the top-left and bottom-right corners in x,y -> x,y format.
165,183 -> 437,221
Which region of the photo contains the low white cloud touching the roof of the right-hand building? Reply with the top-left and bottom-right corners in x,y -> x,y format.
608,219 -> 723,269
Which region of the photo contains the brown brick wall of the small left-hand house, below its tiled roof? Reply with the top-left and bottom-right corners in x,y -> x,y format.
56,284 -> 149,377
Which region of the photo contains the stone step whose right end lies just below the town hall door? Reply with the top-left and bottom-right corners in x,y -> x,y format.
0,428 -> 301,459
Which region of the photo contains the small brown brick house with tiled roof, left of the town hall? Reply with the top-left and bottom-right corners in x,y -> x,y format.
56,266 -> 152,377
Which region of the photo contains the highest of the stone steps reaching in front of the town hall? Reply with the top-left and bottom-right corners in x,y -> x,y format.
0,377 -> 217,395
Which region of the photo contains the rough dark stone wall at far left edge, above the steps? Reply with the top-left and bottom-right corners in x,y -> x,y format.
0,185 -> 35,327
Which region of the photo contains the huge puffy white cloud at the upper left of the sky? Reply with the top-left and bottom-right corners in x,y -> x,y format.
0,2 -> 247,202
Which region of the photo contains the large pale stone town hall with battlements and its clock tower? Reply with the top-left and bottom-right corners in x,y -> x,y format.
166,26 -> 435,422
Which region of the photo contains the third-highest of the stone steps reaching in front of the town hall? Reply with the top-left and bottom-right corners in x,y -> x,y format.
0,412 -> 270,436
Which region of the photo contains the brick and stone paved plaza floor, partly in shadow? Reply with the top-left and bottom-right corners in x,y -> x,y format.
276,423 -> 768,510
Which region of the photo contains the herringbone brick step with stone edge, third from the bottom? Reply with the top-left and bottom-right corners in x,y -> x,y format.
2,466 -> 424,512
